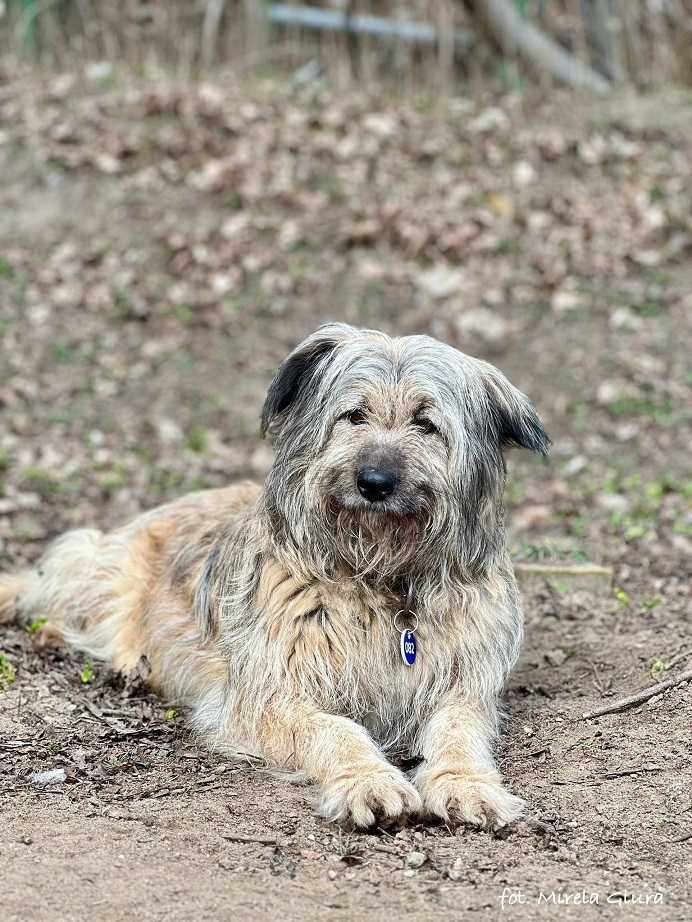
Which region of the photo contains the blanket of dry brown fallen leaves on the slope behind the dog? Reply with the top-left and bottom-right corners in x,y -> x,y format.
0,76 -> 692,604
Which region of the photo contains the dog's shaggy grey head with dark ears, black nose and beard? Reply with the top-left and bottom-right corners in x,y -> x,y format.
262,324 -> 550,578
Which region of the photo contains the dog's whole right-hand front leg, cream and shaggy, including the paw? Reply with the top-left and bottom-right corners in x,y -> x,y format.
414,698 -> 524,829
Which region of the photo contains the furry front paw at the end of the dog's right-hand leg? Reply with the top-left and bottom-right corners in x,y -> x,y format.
418,771 -> 525,829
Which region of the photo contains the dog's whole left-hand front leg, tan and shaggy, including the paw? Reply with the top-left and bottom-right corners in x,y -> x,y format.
262,702 -> 421,828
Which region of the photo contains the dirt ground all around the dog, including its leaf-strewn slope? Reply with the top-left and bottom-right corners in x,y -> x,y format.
0,77 -> 692,922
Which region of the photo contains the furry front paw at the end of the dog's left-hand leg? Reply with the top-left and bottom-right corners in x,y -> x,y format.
318,767 -> 421,829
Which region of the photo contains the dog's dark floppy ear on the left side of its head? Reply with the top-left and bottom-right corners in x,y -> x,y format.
262,323 -> 356,436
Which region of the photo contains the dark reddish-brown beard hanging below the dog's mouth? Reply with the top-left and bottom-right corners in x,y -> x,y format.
327,501 -> 432,578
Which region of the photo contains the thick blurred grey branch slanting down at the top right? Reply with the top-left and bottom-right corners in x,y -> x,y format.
472,0 -> 610,93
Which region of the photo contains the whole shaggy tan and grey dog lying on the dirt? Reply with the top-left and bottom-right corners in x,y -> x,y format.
0,324 -> 550,827
